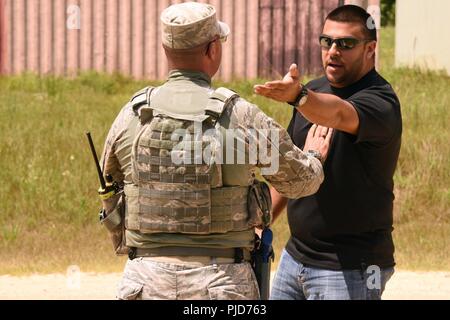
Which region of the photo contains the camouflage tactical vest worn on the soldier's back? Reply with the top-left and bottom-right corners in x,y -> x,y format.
125,88 -> 271,234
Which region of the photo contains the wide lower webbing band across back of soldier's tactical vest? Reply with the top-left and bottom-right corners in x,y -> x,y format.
125,186 -> 248,234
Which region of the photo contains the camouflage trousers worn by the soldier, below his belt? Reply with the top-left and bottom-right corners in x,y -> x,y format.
117,257 -> 259,300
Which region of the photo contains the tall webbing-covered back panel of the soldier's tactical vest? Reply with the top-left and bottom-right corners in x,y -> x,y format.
136,117 -> 211,233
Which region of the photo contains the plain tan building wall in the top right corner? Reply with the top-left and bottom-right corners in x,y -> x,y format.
395,0 -> 450,75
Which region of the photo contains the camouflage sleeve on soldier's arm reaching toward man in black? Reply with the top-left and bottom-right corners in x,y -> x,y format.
229,98 -> 324,199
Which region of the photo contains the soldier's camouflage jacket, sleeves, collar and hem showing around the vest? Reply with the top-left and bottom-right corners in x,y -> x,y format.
101,71 -> 323,250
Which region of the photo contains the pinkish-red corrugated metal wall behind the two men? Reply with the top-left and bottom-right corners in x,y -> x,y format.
0,0 -> 384,80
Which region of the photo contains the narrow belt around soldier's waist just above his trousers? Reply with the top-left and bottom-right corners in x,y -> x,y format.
128,247 -> 251,263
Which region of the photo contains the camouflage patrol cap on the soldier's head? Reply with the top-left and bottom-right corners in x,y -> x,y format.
161,2 -> 230,49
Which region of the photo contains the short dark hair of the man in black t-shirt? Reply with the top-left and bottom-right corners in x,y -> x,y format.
325,4 -> 377,41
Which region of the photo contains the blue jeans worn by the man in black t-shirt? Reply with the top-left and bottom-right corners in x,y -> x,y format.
270,250 -> 394,300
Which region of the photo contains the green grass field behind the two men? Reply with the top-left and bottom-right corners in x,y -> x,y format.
0,28 -> 450,274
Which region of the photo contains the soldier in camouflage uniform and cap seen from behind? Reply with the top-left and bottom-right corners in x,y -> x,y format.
101,3 -> 329,299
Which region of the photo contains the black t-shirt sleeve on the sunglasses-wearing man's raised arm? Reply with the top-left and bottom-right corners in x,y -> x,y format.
347,86 -> 399,146
